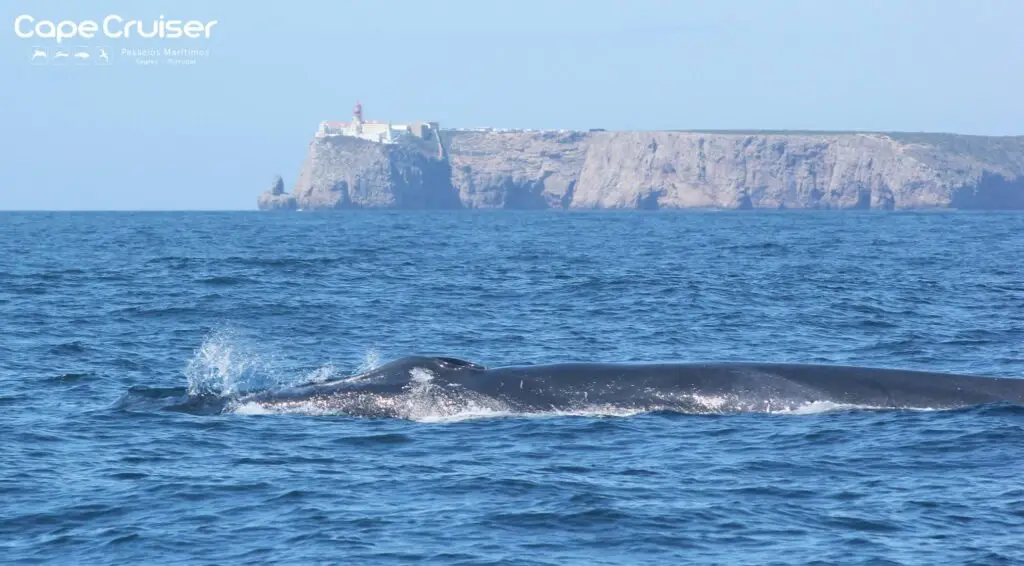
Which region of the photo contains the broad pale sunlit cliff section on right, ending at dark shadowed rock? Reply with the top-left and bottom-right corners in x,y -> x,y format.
572,132 -> 917,209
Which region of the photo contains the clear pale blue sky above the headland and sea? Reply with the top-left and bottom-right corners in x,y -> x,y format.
0,0 -> 1024,210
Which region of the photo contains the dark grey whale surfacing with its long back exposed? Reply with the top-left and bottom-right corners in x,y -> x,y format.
224,356 -> 1024,418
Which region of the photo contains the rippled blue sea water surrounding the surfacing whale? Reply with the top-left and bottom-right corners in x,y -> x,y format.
0,211 -> 1024,565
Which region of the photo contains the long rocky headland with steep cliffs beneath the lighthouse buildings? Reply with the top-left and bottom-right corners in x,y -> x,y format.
259,131 -> 1024,210
